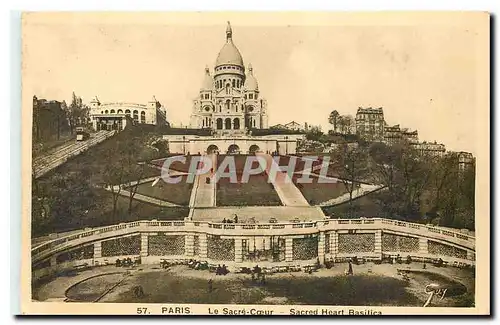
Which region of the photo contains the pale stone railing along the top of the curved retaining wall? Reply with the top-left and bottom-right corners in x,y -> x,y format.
31,218 -> 475,260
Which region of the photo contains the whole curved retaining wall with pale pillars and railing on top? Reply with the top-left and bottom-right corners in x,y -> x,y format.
31,218 -> 475,274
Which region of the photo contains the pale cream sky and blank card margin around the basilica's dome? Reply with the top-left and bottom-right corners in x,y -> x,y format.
23,13 -> 489,153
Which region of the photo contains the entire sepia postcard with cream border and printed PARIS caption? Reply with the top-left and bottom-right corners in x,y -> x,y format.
21,12 -> 490,316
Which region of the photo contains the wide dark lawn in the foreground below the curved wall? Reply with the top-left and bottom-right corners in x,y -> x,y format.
108,271 -> 422,306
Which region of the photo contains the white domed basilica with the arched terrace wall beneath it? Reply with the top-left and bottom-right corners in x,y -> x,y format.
163,22 -> 304,155
